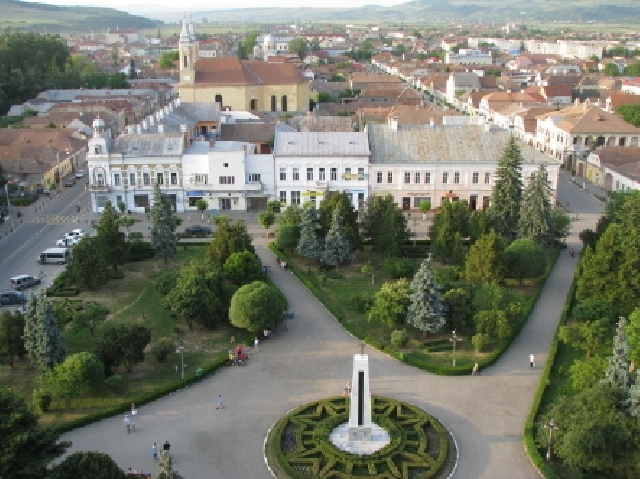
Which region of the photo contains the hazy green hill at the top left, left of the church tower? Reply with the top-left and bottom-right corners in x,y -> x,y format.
0,0 -> 158,33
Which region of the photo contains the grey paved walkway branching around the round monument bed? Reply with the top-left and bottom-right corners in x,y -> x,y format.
63,174 -> 602,479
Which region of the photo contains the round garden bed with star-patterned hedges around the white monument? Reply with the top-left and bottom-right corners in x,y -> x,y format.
265,397 -> 456,479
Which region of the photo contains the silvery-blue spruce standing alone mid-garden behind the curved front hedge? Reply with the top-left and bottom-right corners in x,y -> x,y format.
407,256 -> 447,334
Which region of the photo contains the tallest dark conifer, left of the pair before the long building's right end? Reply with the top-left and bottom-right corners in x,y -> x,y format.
488,135 -> 522,241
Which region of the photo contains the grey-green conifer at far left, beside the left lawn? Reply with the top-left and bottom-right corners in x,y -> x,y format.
24,291 -> 67,371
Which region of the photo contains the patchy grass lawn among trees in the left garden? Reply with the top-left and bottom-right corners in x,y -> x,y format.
0,245 -> 250,424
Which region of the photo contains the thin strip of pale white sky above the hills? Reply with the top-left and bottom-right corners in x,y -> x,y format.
25,0 -> 408,13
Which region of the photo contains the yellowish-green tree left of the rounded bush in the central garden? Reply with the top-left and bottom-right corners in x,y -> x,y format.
464,230 -> 504,283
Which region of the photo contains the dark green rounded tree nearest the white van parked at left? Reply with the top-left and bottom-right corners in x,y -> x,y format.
65,238 -> 109,289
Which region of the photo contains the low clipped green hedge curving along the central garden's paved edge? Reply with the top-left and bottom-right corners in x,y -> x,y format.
269,243 -> 560,376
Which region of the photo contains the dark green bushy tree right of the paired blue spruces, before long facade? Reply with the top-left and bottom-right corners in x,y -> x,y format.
363,195 -> 409,258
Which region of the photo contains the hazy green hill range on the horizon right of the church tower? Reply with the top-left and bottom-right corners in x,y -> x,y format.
171,0 -> 640,25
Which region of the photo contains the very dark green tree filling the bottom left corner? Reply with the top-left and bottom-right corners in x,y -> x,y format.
0,388 -> 71,479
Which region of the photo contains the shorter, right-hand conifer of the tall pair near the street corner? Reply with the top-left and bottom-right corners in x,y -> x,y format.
518,165 -> 553,247
